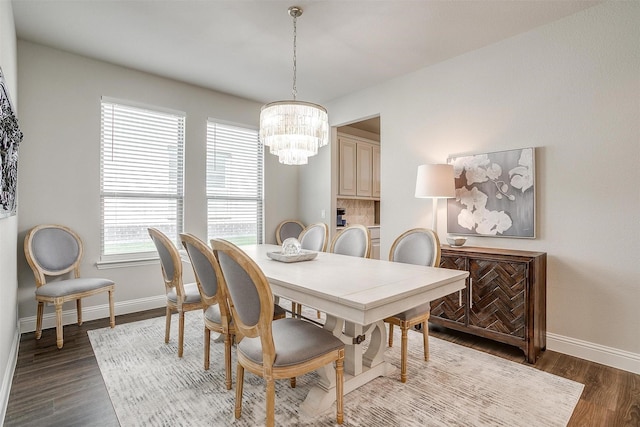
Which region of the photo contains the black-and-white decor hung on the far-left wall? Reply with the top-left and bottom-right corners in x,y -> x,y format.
0,69 -> 22,218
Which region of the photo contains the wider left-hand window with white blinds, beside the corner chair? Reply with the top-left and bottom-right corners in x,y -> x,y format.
100,98 -> 185,261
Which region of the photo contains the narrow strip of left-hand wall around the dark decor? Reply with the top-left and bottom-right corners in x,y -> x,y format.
0,1 -> 19,420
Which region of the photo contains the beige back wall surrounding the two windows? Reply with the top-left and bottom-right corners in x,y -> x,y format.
18,41 -> 298,331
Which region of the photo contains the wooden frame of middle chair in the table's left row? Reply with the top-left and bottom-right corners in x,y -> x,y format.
180,233 -> 236,390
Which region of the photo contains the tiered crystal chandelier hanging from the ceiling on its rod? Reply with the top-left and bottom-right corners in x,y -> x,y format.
260,6 -> 329,165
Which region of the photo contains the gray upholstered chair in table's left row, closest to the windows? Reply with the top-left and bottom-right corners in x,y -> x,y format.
148,227 -> 203,357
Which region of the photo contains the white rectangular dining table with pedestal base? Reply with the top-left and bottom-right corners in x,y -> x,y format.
240,244 -> 469,416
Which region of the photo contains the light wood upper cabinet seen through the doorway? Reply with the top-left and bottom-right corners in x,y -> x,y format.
338,134 -> 380,200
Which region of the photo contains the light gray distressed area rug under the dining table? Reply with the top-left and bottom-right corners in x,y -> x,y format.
89,312 -> 584,427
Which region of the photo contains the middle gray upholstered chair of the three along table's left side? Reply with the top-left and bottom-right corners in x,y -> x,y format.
180,233 -> 236,390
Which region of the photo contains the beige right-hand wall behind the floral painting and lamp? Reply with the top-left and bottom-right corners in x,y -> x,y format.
316,2 -> 640,372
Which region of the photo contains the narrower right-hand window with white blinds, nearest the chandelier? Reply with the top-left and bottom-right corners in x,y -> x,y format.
207,120 -> 264,245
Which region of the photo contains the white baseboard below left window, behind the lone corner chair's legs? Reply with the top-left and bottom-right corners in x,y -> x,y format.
20,295 -> 167,334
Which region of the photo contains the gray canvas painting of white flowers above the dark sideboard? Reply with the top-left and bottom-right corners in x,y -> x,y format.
447,148 -> 535,238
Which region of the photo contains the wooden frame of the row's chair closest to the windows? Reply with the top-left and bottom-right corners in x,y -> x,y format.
148,227 -> 203,357
